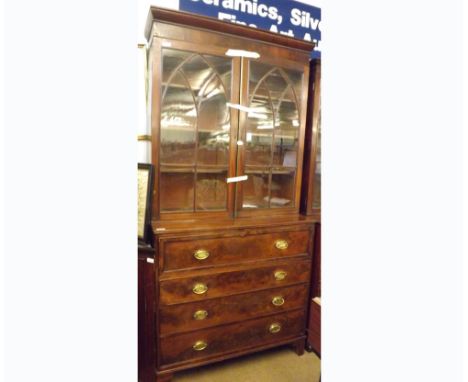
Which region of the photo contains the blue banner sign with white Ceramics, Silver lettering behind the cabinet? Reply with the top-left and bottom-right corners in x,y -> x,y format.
179,0 -> 321,58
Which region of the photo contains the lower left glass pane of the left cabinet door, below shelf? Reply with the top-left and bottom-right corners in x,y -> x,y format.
159,167 -> 195,211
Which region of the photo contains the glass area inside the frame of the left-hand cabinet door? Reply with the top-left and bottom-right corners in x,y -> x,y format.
160,48 -> 232,211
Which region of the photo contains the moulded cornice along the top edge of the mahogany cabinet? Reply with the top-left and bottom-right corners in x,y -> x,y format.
145,6 -> 315,52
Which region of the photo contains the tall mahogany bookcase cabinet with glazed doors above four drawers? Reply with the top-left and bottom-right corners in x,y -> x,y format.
139,7 -> 317,381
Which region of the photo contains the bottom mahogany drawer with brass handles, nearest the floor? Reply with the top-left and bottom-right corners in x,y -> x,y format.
160,310 -> 305,365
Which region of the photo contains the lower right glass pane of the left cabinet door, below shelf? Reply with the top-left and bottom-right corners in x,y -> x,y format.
195,169 -> 227,211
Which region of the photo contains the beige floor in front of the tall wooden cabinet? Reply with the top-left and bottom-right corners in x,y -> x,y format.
173,347 -> 320,382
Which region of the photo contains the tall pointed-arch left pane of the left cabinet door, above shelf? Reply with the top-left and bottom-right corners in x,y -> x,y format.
160,67 -> 197,164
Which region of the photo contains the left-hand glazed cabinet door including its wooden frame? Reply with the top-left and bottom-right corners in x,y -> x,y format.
153,41 -> 240,219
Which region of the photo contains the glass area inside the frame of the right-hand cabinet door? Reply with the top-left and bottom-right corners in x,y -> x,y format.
243,61 -> 303,208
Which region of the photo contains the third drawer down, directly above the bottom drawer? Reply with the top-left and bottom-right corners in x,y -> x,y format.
159,284 -> 308,336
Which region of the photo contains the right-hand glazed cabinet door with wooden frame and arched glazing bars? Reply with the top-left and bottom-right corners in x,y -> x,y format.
236,58 -> 308,216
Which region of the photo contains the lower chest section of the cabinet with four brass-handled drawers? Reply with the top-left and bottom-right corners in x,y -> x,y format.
156,225 -> 313,369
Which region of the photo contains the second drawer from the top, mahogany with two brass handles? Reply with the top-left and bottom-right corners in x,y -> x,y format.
159,260 -> 311,305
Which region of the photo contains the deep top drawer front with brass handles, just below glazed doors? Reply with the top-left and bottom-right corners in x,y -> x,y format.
161,230 -> 310,270
